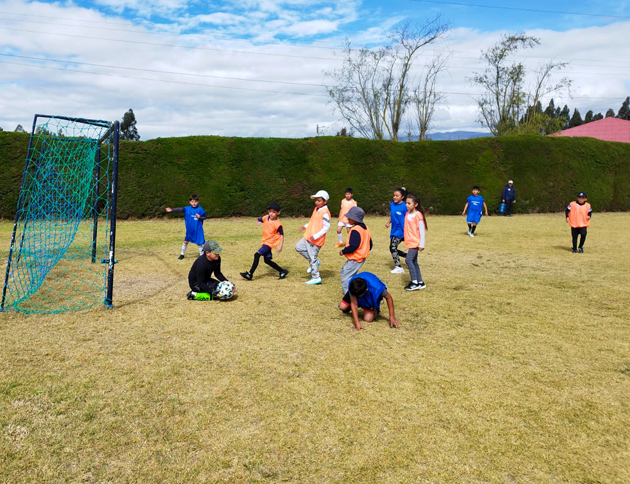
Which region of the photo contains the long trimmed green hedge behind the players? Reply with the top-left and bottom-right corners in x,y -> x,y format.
0,132 -> 630,218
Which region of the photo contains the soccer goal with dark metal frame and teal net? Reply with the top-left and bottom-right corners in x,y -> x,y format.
1,114 -> 119,313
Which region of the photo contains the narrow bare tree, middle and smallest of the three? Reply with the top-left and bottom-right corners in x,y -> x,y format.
411,55 -> 450,140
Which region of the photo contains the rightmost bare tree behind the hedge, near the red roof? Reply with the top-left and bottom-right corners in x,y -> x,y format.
471,32 -> 571,136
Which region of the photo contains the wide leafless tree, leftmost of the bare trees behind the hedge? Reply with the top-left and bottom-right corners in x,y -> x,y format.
326,16 -> 449,141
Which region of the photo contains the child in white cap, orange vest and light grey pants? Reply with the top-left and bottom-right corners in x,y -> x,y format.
295,190 -> 330,286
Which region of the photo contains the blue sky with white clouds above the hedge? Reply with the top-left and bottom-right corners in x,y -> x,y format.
0,0 -> 630,140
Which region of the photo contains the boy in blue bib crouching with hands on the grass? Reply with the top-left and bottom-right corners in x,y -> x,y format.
339,272 -> 400,330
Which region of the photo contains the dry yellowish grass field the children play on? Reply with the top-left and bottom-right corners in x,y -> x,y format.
0,213 -> 630,484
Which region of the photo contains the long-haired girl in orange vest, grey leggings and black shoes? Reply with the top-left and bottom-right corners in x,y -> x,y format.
405,193 -> 428,291
